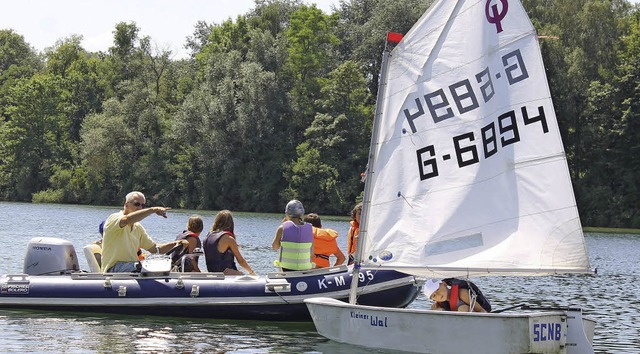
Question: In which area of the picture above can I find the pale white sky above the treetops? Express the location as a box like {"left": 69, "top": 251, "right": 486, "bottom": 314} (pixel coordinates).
{"left": 0, "top": 0, "right": 339, "bottom": 59}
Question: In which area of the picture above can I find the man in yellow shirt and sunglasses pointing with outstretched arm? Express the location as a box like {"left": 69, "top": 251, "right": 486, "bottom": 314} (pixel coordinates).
{"left": 101, "top": 192, "right": 189, "bottom": 273}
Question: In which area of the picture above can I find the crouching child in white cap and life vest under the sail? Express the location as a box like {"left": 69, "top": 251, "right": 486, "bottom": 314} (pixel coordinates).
{"left": 423, "top": 278, "right": 491, "bottom": 312}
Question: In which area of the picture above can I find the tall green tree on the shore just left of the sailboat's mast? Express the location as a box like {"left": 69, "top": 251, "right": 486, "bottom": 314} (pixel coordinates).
{"left": 288, "top": 61, "right": 374, "bottom": 214}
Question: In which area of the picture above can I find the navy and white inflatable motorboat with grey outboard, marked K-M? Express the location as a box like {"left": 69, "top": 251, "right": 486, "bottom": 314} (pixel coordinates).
{"left": 0, "top": 237, "right": 421, "bottom": 321}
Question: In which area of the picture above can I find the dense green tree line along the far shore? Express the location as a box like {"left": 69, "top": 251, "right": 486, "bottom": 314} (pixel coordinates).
{"left": 0, "top": 0, "right": 640, "bottom": 227}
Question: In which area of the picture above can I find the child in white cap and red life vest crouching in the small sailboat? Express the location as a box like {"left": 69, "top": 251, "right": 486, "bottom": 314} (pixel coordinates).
{"left": 423, "top": 278, "right": 491, "bottom": 312}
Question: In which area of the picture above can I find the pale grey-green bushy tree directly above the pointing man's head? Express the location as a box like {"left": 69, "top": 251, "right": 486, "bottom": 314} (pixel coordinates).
{"left": 81, "top": 83, "right": 172, "bottom": 203}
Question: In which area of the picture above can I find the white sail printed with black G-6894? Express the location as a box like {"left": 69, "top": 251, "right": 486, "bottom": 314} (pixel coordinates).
{"left": 358, "top": 0, "right": 589, "bottom": 277}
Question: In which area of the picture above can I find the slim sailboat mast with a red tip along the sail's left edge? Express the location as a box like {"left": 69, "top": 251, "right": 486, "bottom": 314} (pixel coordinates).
{"left": 349, "top": 32, "right": 402, "bottom": 304}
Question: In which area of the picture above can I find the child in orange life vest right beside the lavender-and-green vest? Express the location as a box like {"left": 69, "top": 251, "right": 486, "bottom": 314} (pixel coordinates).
{"left": 304, "top": 213, "right": 345, "bottom": 268}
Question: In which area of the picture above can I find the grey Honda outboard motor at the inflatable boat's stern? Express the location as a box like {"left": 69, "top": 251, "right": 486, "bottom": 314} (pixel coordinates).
{"left": 22, "top": 237, "right": 80, "bottom": 275}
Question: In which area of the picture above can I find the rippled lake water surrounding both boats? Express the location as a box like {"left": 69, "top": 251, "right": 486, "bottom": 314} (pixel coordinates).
{"left": 0, "top": 202, "right": 640, "bottom": 353}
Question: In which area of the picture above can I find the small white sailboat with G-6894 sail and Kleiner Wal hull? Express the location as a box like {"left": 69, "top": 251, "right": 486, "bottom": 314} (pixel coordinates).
{"left": 305, "top": 0, "right": 595, "bottom": 353}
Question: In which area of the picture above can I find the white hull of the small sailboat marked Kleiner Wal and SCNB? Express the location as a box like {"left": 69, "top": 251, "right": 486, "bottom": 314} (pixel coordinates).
{"left": 305, "top": 298, "right": 595, "bottom": 354}
